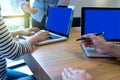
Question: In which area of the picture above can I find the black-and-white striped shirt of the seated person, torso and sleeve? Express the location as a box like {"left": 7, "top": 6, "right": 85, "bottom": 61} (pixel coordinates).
{"left": 0, "top": 7, "right": 31, "bottom": 80}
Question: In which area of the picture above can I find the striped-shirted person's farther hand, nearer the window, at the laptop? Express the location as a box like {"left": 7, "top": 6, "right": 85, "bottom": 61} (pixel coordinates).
{"left": 21, "top": 27, "right": 40, "bottom": 36}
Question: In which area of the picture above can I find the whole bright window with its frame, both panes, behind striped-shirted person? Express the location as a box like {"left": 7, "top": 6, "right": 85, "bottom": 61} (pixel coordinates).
{"left": 0, "top": 0, "right": 29, "bottom": 31}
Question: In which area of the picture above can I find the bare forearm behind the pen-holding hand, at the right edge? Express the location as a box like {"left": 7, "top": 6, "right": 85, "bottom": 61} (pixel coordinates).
{"left": 106, "top": 44, "right": 120, "bottom": 58}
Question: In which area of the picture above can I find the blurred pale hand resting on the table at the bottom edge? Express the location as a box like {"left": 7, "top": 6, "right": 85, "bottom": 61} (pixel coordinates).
{"left": 62, "top": 68, "right": 93, "bottom": 80}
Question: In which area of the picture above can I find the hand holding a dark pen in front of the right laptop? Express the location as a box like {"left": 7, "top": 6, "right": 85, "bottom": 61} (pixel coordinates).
{"left": 81, "top": 34, "right": 108, "bottom": 53}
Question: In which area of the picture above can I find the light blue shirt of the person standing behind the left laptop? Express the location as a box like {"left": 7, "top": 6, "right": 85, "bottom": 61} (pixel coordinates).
{"left": 21, "top": 0, "right": 70, "bottom": 22}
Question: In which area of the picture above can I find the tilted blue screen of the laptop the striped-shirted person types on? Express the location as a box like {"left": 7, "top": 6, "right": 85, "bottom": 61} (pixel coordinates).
{"left": 46, "top": 7, "right": 72, "bottom": 36}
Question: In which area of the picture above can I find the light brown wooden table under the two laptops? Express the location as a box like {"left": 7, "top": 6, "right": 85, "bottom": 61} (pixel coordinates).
{"left": 24, "top": 27, "right": 120, "bottom": 80}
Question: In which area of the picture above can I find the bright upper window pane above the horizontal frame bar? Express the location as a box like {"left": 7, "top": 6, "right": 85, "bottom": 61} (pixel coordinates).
{"left": 1, "top": 0, "right": 24, "bottom": 16}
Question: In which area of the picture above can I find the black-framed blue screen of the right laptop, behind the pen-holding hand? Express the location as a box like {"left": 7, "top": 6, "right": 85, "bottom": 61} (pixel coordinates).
{"left": 82, "top": 8, "right": 120, "bottom": 40}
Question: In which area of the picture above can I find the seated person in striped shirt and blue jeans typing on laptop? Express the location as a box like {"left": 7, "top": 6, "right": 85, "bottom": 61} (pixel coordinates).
{"left": 0, "top": 6, "right": 50, "bottom": 80}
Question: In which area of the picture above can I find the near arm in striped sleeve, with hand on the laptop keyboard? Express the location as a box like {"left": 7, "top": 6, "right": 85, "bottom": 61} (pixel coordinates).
{"left": 0, "top": 7, "right": 50, "bottom": 59}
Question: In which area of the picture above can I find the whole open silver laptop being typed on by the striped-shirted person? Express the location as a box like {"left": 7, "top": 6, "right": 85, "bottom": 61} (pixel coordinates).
{"left": 23, "top": 5, "right": 74, "bottom": 45}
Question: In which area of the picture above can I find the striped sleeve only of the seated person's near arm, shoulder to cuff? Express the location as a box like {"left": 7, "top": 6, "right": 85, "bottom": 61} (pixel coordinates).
{"left": 0, "top": 8, "right": 31, "bottom": 59}
